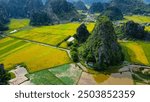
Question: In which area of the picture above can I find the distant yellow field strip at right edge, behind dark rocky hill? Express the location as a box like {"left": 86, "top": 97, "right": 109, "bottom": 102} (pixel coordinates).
{"left": 124, "top": 15, "right": 150, "bottom": 23}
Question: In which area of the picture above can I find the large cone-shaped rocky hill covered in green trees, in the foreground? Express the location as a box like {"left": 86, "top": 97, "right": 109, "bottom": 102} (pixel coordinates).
{"left": 80, "top": 16, "right": 124, "bottom": 70}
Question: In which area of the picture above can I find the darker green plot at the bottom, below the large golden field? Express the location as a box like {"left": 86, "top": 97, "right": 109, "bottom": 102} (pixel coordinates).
{"left": 27, "top": 70, "right": 64, "bottom": 85}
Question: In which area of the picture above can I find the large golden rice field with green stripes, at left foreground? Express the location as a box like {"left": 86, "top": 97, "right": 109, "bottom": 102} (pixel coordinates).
{"left": 0, "top": 38, "right": 71, "bottom": 73}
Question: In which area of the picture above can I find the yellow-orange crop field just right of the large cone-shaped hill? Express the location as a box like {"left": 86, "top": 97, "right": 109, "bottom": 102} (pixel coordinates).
{"left": 124, "top": 42, "right": 149, "bottom": 65}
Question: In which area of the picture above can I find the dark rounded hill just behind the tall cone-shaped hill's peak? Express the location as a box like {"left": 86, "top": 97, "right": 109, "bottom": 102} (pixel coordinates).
{"left": 102, "top": 7, "right": 123, "bottom": 21}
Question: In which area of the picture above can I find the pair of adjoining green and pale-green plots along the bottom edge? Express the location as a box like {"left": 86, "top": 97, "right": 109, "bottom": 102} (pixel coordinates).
{"left": 27, "top": 64, "right": 82, "bottom": 85}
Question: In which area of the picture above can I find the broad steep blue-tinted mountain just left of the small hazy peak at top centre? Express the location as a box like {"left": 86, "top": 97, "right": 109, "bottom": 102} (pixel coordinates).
{"left": 46, "top": 0, "right": 78, "bottom": 21}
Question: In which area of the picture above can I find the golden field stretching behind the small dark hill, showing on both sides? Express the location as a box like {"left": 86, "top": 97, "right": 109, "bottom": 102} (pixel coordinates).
{"left": 10, "top": 20, "right": 94, "bottom": 45}
